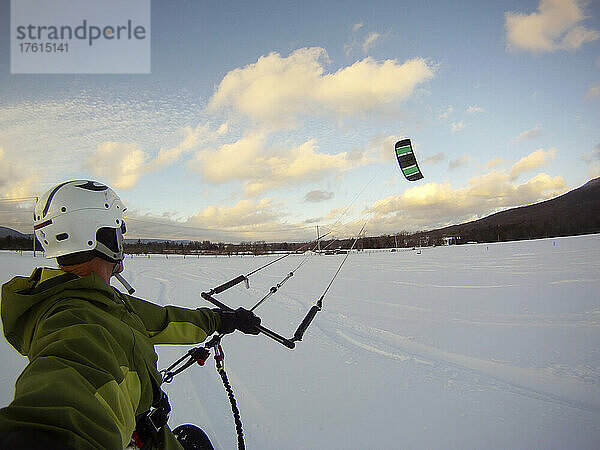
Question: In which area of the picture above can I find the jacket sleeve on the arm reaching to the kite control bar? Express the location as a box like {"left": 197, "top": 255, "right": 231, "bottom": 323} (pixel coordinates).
{"left": 123, "top": 294, "right": 221, "bottom": 344}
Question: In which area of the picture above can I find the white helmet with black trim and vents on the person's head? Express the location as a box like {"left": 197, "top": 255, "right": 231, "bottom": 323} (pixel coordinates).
{"left": 33, "top": 180, "right": 126, "bottom": 265}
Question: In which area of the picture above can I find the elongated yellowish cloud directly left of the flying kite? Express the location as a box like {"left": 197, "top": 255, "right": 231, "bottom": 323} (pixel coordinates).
{"left": 189, "top": 131, "right": 371, "bottom": 196}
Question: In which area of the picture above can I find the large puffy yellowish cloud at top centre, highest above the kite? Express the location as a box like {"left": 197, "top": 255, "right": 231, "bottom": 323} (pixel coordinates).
{"left": 209, "top": 47, "right": 434, "bottom": 127}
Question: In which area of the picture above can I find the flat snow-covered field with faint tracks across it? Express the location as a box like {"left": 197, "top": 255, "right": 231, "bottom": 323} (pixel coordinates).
{"left": 0, "top": 235, "right": 600, "bottom": 449}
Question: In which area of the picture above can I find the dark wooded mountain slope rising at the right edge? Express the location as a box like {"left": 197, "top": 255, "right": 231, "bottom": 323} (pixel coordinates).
{"left": 425, "top": 178, "right": 600, "bottom": 242}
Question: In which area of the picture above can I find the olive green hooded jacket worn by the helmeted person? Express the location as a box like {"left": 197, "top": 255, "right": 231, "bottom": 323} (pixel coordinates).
{"left": 0, "top": 268, "right": 221, "bottom": 449}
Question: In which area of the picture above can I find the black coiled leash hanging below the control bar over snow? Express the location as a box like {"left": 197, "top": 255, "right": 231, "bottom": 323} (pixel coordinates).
{"left": 161, "top": 334, "right": 246, "bottom": 450}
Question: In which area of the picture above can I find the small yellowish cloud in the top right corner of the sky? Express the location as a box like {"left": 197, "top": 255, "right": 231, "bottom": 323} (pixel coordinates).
{"left": 505, "top": 0, "right": 600, "bottom": 53}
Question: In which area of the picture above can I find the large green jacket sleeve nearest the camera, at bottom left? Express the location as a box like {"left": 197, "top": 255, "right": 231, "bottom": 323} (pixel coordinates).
{"left": 0, "top": 304, "right": 141, "bottom": 449}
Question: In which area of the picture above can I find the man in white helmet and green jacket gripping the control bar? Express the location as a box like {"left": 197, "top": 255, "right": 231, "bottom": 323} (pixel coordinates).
{"left": 0, "top": 180, "right": 260, "bottom": 450}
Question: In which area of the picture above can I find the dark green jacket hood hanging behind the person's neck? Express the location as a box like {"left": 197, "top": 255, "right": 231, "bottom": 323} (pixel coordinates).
{"left": 0, "top": 267, "right": 115, "bottom": 356}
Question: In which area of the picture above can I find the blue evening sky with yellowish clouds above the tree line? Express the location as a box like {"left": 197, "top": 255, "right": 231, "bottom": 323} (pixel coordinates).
{"left": 0, "top": 0, "right": 600, "bottom": 242}
